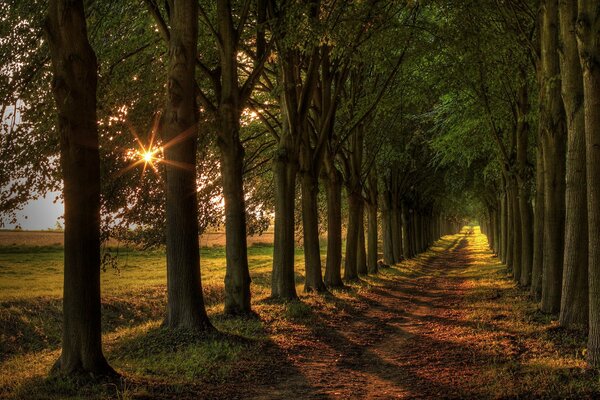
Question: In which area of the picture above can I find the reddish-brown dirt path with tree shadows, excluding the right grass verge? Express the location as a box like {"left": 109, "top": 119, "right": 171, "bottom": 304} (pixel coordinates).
{"left": 252, "top": 232, "right": 493, "bottom": 399}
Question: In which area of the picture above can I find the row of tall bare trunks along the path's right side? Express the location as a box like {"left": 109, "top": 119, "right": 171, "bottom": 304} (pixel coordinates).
{"left": 480, "top": 0, "right": 600, "bottom": 366}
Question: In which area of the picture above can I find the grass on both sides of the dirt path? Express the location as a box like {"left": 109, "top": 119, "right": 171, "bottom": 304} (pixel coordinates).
{"left": 0, "top": 230, "right": 600, "bottom": 399}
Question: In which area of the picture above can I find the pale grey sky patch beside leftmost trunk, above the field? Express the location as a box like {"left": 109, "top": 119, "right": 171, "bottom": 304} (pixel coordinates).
{"left": 2, "top": 192, "right": 64, "bottom": 230}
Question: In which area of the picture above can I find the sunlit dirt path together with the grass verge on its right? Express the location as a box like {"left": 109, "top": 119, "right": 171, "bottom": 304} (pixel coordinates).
{"left": 259, "top": 228, "right": 600, "bottom": 399}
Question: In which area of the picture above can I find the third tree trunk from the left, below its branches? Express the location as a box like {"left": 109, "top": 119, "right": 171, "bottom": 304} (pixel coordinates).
{"left": 219, "top": 120, "right": 251, "bottom": 315}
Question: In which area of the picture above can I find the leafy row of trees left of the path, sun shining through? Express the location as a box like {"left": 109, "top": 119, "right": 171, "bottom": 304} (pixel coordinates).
{"left": 0, "top": 0, "right": 472, "bottom": 375}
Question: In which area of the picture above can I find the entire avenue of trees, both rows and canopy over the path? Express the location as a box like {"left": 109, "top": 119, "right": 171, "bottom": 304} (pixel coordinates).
{"left": 0, "top": 0, "right": 600, "bottom": 375}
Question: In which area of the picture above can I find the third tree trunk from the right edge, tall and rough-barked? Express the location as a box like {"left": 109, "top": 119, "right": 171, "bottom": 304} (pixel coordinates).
{"left": 540, "top": 0, "right": 566, "bottom": 313}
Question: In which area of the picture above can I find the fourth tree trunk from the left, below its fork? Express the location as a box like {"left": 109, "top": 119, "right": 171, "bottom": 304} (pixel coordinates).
{"left": 271, "top": 135, "right": 298, "bottom": 300}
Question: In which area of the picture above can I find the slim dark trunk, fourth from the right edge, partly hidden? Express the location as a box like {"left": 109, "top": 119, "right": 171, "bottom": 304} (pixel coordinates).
{"left": 530, "top": 147, "right": 545, "bottom": 300}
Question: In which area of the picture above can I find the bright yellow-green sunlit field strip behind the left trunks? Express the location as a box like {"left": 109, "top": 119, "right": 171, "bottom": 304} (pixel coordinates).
{"left": 0, "top": 238, "right": 304, "bottom": 300}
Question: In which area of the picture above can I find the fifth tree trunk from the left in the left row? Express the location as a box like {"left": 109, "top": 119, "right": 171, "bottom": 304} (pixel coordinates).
{"left": 302, "top": 172, "right": 326, "bottom": 292}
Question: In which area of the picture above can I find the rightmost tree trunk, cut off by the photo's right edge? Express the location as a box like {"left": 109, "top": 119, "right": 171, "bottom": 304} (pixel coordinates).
{"left": 577, "top": 0, "right": 600, "bottom": 367}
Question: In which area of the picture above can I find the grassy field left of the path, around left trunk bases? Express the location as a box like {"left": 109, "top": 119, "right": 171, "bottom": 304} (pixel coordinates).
{"left": 0, "top": 231, "right": 324, "bottom": 399}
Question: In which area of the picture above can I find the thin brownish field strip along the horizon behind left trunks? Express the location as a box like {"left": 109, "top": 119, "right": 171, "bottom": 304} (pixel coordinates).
{"left": 0, "top": 230, "right": 273, "bottom": 247}
